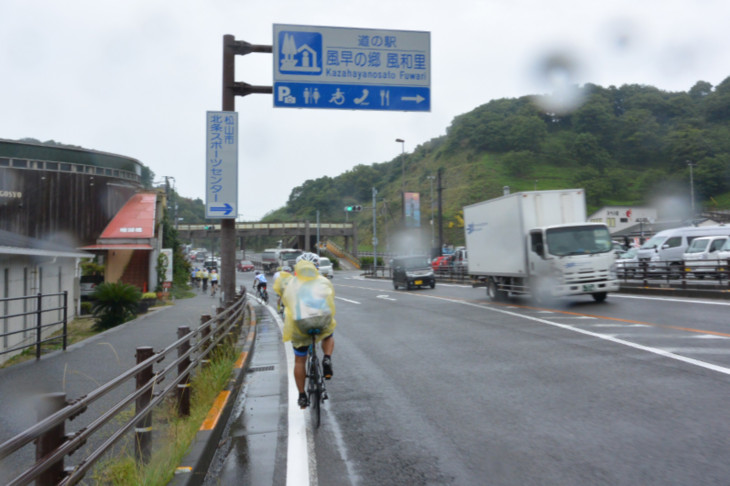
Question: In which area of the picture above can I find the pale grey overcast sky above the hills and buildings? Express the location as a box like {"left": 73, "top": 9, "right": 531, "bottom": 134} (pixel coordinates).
{"left": 0, "top": 0, "right": 730, "bottom": 221}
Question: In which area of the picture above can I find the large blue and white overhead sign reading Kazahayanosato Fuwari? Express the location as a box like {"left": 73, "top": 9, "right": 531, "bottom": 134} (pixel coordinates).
{"left": 273, "top": 24, "right": 431, "bottom": 111}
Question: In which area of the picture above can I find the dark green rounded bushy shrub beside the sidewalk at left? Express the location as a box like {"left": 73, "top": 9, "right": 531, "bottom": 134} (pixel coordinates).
{"left": 93, "top": 282, "right": 142, "bottom": 330}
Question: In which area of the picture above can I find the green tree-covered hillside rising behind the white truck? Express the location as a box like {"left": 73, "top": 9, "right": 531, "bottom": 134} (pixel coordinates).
{"left": 265, "top": 78, "right": 730, "bottom": 249}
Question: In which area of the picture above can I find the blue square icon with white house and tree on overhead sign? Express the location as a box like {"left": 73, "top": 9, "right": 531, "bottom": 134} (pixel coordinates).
{"left": 278, "top": 31, "right": 322, "bottom": 75}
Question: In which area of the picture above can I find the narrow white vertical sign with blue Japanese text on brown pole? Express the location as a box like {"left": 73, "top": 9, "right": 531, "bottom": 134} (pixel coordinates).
{"left": 205, "top": 111, "right": 238, "bottom": 219}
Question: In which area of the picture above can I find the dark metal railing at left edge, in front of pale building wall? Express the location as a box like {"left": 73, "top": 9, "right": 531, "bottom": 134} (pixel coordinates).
{"left": 0, "top": 291, "right": 68, "bottom": 359}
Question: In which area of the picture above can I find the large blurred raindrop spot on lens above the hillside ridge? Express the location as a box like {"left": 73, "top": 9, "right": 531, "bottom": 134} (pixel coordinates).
{"left": 533, "top": 50, "right": 584, "bottom": 114}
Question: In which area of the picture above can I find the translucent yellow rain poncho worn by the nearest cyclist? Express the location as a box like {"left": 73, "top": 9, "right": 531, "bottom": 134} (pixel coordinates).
{"left": 282, "top": 260, "right": 337, "bottom": 347}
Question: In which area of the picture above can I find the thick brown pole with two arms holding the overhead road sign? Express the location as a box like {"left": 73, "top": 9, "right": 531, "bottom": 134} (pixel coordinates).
{"left": 220, "top": 34, "right": 273, "bottom": 304}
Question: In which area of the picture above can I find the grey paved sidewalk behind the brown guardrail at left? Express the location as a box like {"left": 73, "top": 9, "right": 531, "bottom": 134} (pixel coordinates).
{"left": 0, "top": 294, "right": 225, "bottom": 484}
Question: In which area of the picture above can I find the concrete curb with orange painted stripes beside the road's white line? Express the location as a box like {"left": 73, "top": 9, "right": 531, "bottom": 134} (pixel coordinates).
{"left": 168, "top": 302, "right": 256, "bottom": 486}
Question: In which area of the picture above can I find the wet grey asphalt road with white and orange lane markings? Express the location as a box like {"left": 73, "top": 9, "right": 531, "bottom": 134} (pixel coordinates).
{"left": 209, "top": 272, "right": 730, "bottom": 486}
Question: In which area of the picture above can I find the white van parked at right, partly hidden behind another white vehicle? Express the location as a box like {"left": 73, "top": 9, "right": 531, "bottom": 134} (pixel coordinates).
{"left": 638, "top": 225, "right": 730, "bottom": 274}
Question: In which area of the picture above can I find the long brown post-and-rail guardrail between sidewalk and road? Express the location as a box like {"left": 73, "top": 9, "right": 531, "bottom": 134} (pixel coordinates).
{"left": 0, "top": 289, "right": 247, "bottom": 486}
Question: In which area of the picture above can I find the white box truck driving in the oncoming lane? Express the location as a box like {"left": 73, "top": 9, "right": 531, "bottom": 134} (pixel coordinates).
{"left": 464, "top": 189, "right": 619, "bottom": 302}
